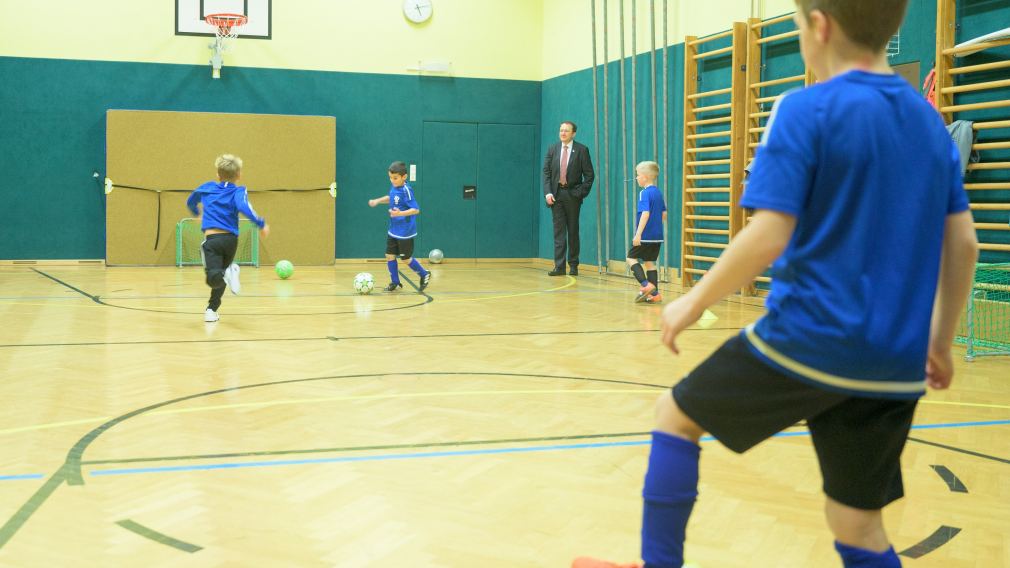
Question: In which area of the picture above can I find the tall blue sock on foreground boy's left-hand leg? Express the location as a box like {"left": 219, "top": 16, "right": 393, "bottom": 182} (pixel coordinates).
{"left": 641, "top": 432, "right": 701, "bottom": 568}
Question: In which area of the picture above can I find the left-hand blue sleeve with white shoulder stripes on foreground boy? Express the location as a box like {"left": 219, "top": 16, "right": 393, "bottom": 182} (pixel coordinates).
{"left": 740, "top": 91, "right": 819, "bottom": 216}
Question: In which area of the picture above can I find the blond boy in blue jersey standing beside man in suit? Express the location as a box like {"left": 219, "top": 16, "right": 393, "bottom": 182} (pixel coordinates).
{"left": 627, "top": 162, "right": 667, "bottom": 304}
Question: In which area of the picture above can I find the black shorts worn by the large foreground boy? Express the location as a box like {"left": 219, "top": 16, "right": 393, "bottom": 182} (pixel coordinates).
{"left": 673, "top": 336, "right": 918, "bottom": 510}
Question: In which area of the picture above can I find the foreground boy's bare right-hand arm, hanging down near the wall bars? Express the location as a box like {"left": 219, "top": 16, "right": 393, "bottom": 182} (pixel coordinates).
{"left": 926, "top": 211, "right": 979, "bottom": 389}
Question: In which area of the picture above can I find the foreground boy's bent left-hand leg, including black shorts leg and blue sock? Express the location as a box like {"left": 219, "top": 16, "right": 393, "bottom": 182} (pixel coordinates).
{"left": 577, "top": 336, "right": 848, "bottom": 568}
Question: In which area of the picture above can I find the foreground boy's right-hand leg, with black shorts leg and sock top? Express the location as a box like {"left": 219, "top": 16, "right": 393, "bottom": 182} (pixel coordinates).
{"left": 808, "top": 398, "right": 917, "bottom": 568}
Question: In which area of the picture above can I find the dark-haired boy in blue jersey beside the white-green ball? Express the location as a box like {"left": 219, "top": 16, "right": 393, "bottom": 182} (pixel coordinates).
{"left": 369, "top": 162, "right": 431, "bottom": 292}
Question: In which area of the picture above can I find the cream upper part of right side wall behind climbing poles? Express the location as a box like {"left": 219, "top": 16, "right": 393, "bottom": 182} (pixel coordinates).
{"left": 543, "top": 0, "right": 796, "bottom": 79}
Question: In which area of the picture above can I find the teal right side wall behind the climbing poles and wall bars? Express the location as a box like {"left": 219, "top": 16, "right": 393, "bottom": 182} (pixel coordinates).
{"left": 539, "top": 0, "right": 1010, "bottom": 267}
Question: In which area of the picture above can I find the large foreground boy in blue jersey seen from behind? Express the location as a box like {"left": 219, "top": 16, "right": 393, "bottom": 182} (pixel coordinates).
{"left": 575, "top": 0, "right": 978, "bottom": 568}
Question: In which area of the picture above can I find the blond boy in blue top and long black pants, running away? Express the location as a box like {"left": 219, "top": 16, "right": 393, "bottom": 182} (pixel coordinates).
{"left": 186, "top": 154, "right": 270, "bottom": 322}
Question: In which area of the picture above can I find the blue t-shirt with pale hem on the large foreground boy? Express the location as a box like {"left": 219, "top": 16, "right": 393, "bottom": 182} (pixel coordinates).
{"left": 740, "top": 71, "right": 969, "bottom": 398}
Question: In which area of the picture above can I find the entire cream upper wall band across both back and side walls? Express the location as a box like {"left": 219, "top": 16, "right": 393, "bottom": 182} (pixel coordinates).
{"left": 0, "top": 0, "right": 795, "bottom": 81}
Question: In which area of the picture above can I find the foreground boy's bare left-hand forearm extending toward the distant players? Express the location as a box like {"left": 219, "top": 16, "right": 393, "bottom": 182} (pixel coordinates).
{"left": 663, "top": 209, "right": 796, "bottom": 354}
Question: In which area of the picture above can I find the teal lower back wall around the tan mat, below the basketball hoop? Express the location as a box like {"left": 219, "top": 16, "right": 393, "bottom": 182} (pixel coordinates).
{"left": 0, "top": 58, "right": 540, "bottom": 259}
